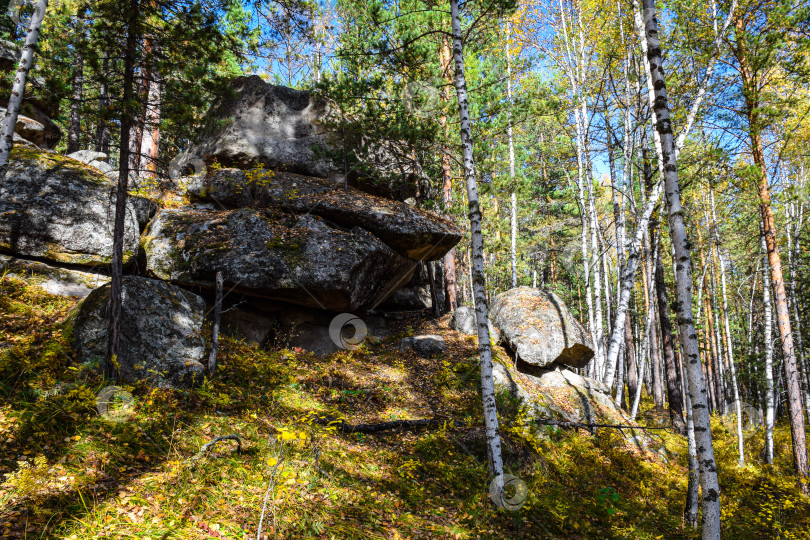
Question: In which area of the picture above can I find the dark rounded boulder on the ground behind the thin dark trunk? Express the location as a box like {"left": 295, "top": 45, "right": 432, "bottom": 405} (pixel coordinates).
{"left": 73, "top": 276, "right": 205, "bottom": 387}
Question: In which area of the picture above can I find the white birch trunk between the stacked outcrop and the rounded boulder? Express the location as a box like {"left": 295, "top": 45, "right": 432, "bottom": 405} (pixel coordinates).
{"left": 450, "top": 0, "right": 503, "bottom": 479}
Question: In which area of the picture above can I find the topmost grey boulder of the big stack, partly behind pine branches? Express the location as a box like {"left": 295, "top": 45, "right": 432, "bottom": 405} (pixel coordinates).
{"left": 190, "top": 75, "right": 427, "bottom": 200}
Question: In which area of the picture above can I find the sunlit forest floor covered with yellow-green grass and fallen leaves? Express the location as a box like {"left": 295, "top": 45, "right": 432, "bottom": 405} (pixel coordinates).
{"left": 0, "top": 276, "right": 810, "bottom": 539}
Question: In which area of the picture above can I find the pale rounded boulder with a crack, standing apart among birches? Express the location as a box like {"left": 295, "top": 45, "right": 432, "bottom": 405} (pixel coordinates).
{"left": 490, "top": 286, "right": 594, "bottom": 368}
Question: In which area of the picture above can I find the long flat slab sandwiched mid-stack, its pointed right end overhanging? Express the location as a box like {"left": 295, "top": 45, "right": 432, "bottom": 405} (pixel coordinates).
{"left": 188, "top": 169, "right": 462, "bottom": 260}
